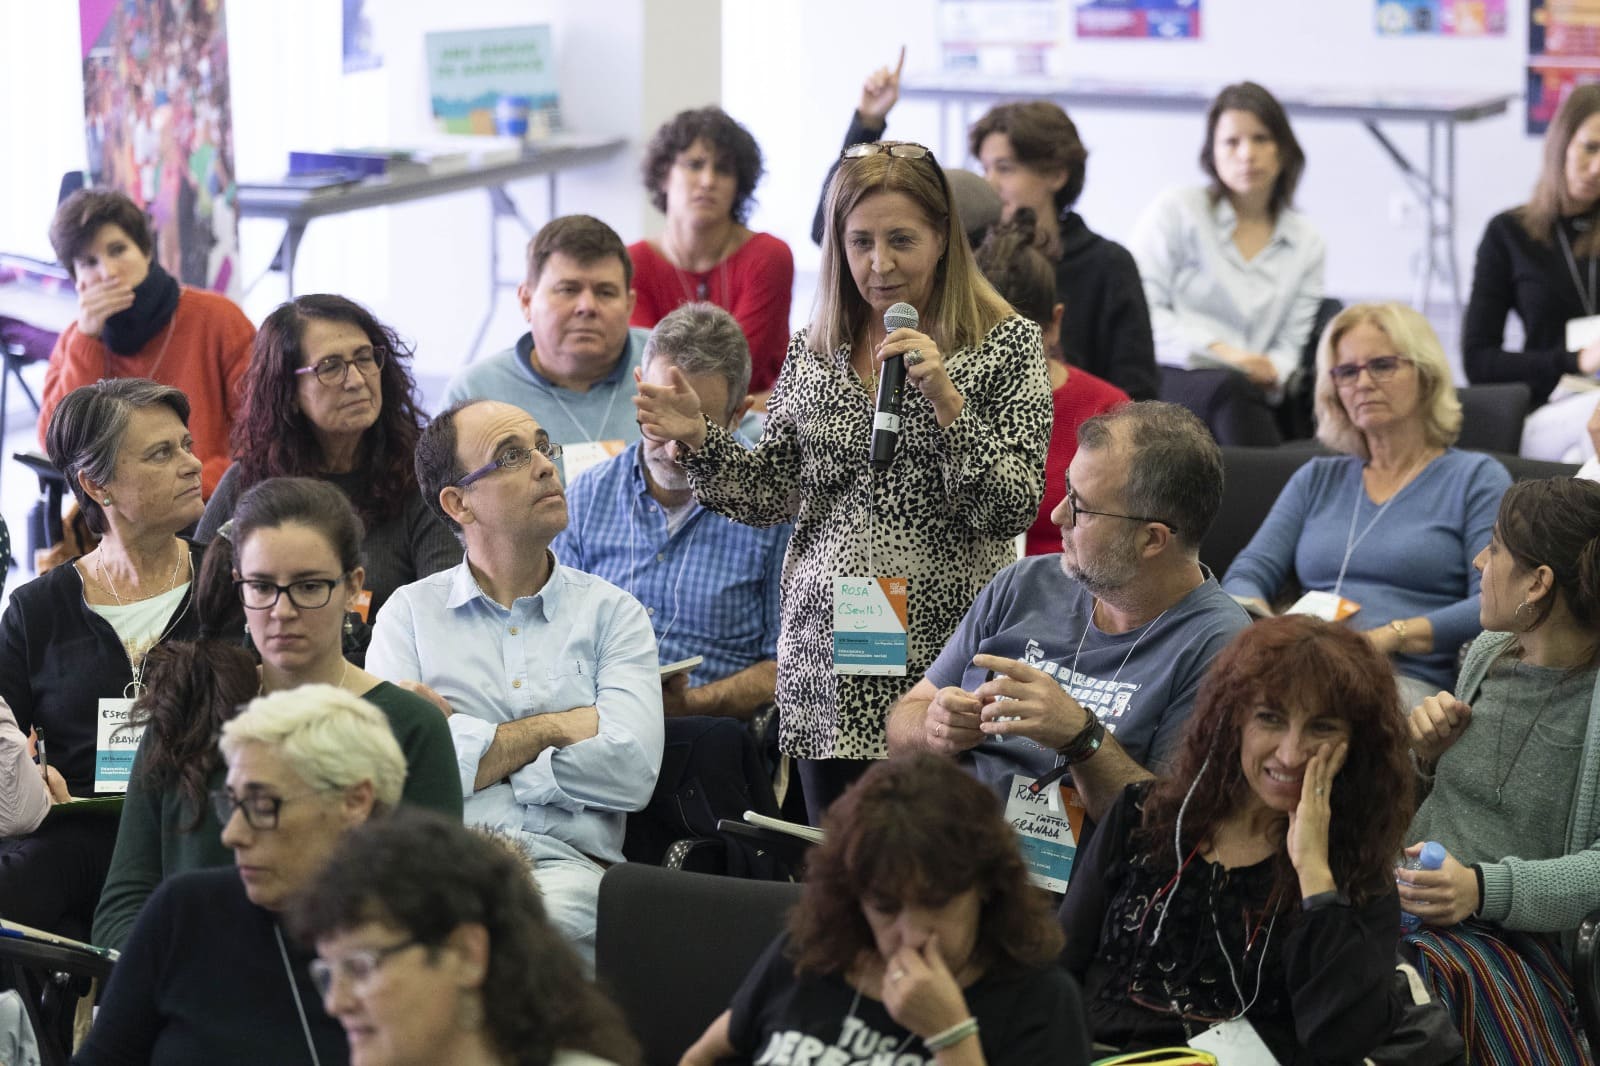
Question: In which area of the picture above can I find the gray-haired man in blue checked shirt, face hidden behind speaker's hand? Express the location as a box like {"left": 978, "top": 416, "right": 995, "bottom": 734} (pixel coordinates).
{"left": 554, "top": 304, "right": 790, "bottom": 719}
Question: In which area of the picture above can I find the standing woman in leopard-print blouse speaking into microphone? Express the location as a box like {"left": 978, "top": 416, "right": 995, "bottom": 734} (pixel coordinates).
{"left": 634, "top": 141, "right": 1051, "bottom": 824}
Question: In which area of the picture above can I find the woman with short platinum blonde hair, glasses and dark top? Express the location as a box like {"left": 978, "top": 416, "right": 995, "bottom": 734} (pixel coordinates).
{"left": 72, "top": 681, "right": 408, "bottom": 1066}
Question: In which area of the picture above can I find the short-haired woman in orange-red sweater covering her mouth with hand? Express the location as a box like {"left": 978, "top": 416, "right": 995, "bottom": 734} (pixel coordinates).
{"left": 38, "top": 189, "right": 256, "bottom": 496}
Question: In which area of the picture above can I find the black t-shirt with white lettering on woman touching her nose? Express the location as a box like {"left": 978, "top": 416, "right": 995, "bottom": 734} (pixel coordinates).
{"left": 728, "top": 935, "right": 1090, "bottom": 1066}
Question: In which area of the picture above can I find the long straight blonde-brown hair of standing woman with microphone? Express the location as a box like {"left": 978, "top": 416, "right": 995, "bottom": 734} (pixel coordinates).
{"left": 806, "top": 141, "right": 1014, "bottom": 354}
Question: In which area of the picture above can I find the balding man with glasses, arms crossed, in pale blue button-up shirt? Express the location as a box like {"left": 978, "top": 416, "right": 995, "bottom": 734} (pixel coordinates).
{"left": 366, "top": 393, "right": 662, "bottom": 959}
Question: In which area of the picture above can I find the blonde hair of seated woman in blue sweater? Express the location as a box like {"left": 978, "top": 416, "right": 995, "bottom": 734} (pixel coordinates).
{"left": 1315, "top": 303, "right": 1461, "bottom": 459}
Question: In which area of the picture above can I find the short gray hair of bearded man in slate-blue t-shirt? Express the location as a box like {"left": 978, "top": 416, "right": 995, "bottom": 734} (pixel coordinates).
{"left": 1078, "top": 400, "right": 1222, "bottom": 552}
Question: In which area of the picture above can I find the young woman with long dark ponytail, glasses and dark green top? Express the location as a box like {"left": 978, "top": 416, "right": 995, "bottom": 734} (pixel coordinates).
{"left": 94, "top": 477, "right": 461, "bottom": 946}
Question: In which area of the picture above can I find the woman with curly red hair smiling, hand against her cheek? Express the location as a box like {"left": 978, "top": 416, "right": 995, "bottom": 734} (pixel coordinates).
{"left": 1061, "top": 615, "right": 1411, "bottom": 1063}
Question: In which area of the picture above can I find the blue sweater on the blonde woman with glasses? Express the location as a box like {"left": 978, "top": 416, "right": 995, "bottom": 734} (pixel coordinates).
{"left": 1222, "top": 448, "right": 1510, "bottom": 688}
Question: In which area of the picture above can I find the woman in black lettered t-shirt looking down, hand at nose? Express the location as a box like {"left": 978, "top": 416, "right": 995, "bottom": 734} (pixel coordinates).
{"left": 683, "top": 754, "right": 1088, "bottom": 1066}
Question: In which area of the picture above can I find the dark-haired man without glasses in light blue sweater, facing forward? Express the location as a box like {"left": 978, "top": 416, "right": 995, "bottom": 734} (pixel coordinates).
{"left": 445, "top": 214, "right": 650, "bottom": 483}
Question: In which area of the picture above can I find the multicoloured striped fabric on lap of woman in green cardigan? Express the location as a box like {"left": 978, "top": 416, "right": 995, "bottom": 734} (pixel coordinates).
{"left": 1402, "top": 919, "right": 1595, "bottom": 1066}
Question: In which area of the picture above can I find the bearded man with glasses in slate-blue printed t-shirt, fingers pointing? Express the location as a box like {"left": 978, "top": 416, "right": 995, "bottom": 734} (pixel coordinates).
{"left": 888, "top": 400, "right": 1250, "bottom": 816}
